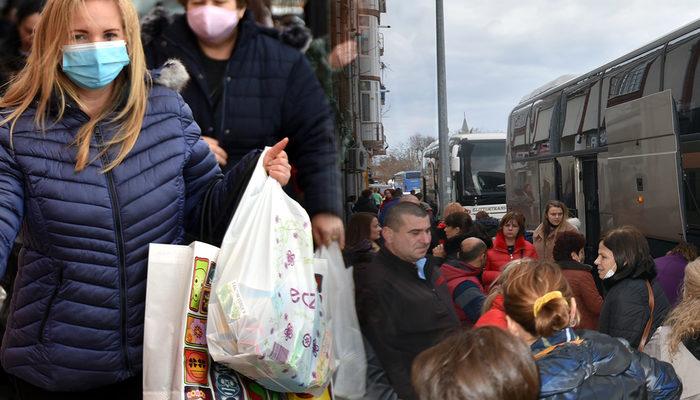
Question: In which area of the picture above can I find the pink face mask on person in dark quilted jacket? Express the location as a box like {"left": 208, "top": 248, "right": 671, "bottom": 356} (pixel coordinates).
{"left": 187, "top": 5, "right": 238, "bottom": 44}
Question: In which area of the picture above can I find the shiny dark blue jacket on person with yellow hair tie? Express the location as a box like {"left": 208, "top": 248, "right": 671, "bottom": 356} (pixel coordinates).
{"left": 531, "top": 328, "right": 683, "bottom": 400}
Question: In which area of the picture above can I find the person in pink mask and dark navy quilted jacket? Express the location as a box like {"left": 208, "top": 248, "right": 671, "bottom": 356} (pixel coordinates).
{"left": 142, "top": 0, "right": 344, "bottom": 245}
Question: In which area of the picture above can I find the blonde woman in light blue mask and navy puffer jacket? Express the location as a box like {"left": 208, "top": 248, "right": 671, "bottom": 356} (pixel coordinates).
{"left": 0, "top": 0, "right": 290, "bottom": 399}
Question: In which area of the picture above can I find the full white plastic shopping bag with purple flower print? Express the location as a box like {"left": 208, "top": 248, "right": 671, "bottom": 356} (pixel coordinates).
{"left": 207, "top": 148, "right": 332, "bottom": 394}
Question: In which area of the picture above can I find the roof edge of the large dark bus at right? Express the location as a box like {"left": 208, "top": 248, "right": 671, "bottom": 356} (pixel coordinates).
{"left": 509, "top": 19, "right": 700, "bottom": 109}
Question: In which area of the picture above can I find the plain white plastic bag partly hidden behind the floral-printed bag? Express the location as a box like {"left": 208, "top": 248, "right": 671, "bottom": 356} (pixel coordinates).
{"left": 316, "top": 242, "right": 367, "bottom": 400}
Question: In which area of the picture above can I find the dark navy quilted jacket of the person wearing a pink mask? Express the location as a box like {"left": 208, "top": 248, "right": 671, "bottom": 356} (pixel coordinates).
{"left": 143, "top": 12, "right": 343, "bottom": 217}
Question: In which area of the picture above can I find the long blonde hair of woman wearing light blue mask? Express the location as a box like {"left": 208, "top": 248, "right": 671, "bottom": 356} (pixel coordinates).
{"left": 0, "top": 0, "right": 151, "bottom": 172}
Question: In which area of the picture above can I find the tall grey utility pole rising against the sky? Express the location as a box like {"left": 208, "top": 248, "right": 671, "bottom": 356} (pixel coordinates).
{"left": 435, "top": 0, "right": 452, "bottom": 213}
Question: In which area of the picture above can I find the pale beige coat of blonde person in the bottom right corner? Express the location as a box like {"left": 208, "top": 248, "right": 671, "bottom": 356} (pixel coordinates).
{"left": 644, "top": 326, "right": 700, "bottom": 400}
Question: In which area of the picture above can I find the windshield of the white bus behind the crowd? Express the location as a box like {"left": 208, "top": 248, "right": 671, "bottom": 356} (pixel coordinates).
{"left": 462, "top": 140, "right": 506, "bottom": 195}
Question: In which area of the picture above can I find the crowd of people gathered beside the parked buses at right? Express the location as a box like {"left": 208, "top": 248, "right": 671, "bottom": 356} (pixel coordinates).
{"left": 346, "top": 191, "right": 700, "bottom": 400}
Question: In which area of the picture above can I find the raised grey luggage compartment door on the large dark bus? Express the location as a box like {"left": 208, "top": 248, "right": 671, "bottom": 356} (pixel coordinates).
{"left": 605, "top": 90, "right": 685, "bottom": 241}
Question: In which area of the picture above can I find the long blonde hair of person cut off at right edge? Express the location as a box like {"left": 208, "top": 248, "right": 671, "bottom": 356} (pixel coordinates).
{"left": 665, "top": 259, "right": 700, "bottom": 355}
